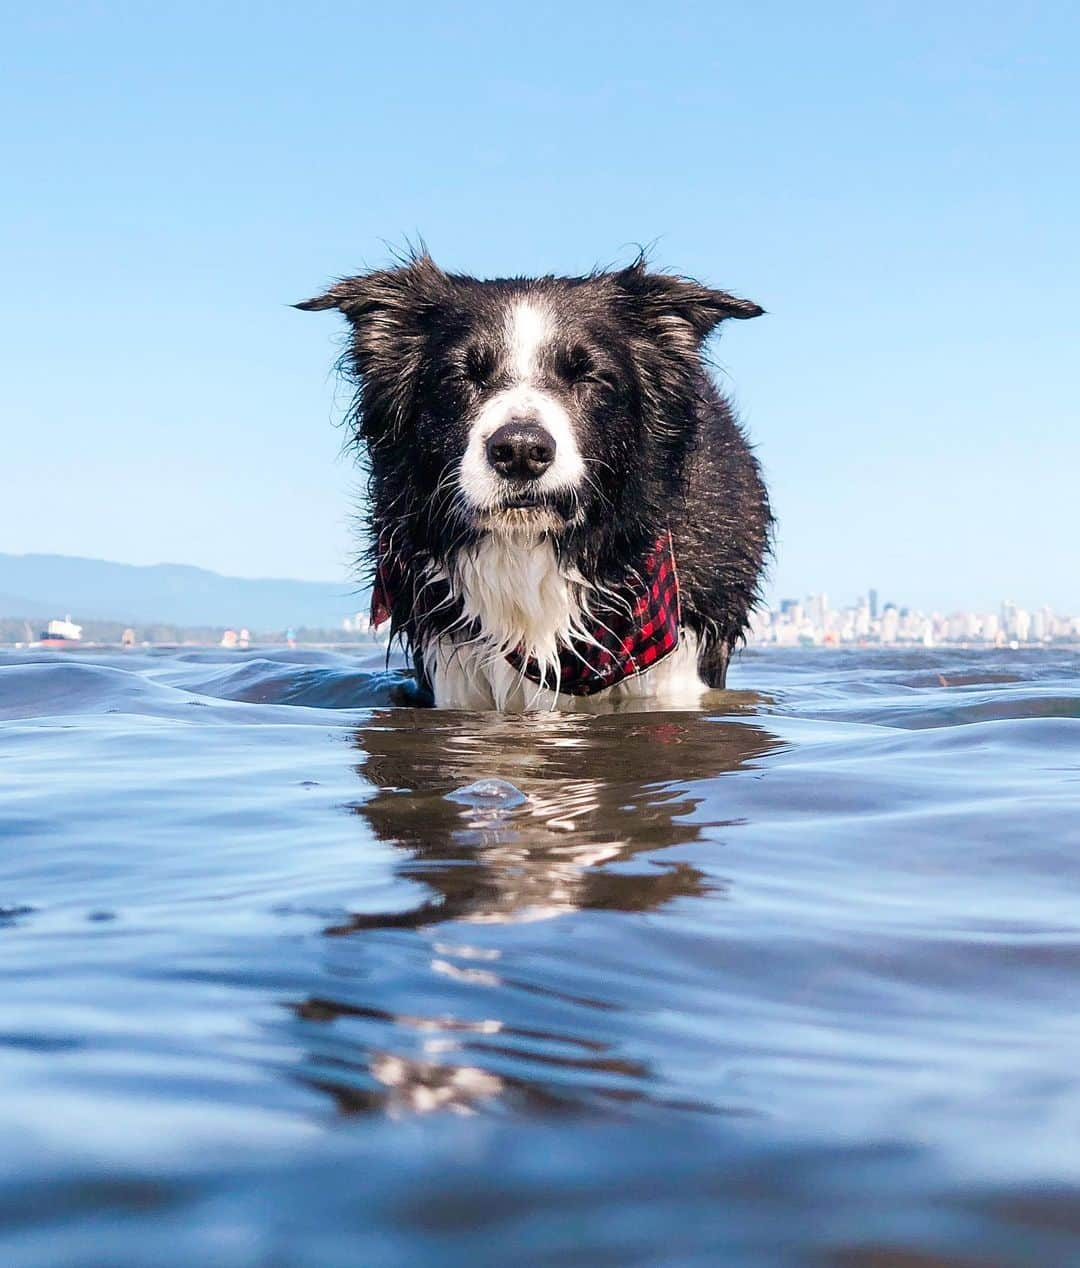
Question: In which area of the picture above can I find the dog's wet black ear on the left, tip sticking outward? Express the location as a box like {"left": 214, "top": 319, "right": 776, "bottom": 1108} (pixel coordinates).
{"left": 293, "top": 254, "right": 450, "bottom": 418}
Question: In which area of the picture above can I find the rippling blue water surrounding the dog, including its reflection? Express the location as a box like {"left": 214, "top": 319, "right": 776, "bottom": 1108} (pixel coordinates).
{"left": 0, "top": 649, "right": 1080, "bottom": 1268}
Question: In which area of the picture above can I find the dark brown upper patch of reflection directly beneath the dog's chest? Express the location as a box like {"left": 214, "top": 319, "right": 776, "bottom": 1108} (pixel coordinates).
{"left": 328, "top": 710, "right": 777, "bottom": 933}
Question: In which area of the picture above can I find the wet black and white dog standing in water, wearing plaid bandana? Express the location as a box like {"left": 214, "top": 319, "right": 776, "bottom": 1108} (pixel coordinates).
{"left": 298, "top": 254, "right": 771, "bottom": 711}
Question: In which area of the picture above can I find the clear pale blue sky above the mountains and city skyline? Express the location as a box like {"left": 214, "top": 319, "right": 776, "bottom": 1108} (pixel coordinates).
{"left": 0, "top": 0, "right": 1080, "bottom": 611}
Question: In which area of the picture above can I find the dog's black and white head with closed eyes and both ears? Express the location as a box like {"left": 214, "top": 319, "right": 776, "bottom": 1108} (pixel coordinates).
{"left": 297, "top": 255, "right": 762, "bottom": 554}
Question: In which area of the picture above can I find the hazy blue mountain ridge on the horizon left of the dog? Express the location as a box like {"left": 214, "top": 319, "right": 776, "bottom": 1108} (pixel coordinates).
{"left": 0, "top": 554, "right": 366, "bottom": 633}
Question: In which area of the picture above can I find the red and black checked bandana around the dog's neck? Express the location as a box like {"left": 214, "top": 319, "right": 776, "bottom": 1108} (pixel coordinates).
{"left": 371, "top": 533, "right": 679, "bottom": 696}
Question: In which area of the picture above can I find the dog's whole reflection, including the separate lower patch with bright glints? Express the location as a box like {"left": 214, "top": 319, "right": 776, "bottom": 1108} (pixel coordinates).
{"left": 297, "top": 709, "right": 778, "bottom": 1113}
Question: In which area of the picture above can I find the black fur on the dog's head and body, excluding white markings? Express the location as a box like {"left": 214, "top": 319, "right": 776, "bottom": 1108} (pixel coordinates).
{"left": 297, "top": 254, "right": 772, "bottom": 687}
